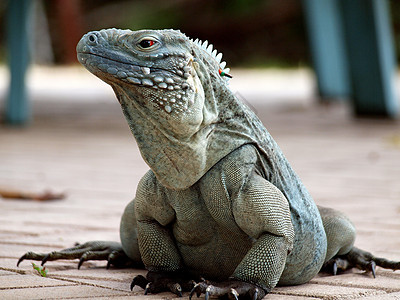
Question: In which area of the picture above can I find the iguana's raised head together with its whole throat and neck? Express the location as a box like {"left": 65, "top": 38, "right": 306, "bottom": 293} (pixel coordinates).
{"left": 77, "top": 29, "right": 248, "bottom": 189}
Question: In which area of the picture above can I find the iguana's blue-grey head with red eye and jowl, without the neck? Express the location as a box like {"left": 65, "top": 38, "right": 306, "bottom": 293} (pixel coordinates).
{"left": 77, "top": 29, "right": 231, "bottom": 139}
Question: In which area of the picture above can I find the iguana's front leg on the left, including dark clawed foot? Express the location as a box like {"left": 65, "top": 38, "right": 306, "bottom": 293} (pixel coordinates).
{"left": 131, "top": 172, "right": 194, "bottom": 296}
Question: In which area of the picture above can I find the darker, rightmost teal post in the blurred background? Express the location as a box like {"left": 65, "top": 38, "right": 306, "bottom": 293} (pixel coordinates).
{"left": 340, "top": 0, "right": 399, "bottom": 117}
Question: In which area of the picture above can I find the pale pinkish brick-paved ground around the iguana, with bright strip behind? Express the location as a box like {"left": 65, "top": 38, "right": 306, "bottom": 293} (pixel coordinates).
{"left": 0, "top": 68, "right": 400, "bottom": 300}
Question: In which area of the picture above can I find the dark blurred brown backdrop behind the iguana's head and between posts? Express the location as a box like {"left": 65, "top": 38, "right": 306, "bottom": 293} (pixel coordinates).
{"left": 0, "top": 0, "right": 400, "bottom": 68}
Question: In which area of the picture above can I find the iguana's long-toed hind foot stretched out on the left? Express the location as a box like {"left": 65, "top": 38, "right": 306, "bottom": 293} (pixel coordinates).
{"left": 17, "top": 241, "right": 138, "bottom": 269}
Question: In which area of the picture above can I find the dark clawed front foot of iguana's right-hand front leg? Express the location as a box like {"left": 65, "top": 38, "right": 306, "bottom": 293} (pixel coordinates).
{"left": 189, "top": 280, "right": 266, "bottom": 300}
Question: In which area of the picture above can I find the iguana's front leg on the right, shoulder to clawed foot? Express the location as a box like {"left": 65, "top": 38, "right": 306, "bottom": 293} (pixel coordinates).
{"left": 191, "top": 170, "right": 294, "bottom": 299}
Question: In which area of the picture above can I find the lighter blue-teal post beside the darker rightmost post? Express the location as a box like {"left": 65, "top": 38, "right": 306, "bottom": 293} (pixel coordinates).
{"left": 303, "top": 0, "right": 350, "bottom": 99}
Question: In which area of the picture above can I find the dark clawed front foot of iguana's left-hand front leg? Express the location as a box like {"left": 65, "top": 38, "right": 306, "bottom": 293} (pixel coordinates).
{"left": 131, "top": 271, "right": 195, "bottom": 297}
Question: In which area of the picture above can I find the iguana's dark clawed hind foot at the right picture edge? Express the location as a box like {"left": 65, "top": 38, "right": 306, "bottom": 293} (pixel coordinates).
{"left": 323, "top": 248, "right": 400, "bottom": 278}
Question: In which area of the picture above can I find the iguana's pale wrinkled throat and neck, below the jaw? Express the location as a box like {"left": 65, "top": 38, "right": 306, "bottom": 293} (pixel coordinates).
{"left": 110, "top": 63, "right": 247, "bottom": 189}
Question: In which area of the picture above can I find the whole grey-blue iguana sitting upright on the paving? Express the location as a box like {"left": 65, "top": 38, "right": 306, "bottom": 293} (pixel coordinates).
{"left": 18, "top": 29, "right": 400, "bottom": 299}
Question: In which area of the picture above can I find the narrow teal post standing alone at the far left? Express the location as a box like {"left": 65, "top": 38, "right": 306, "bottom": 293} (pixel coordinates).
{"left": 5, "top": 0, "right": 32, "bottom": 125}
